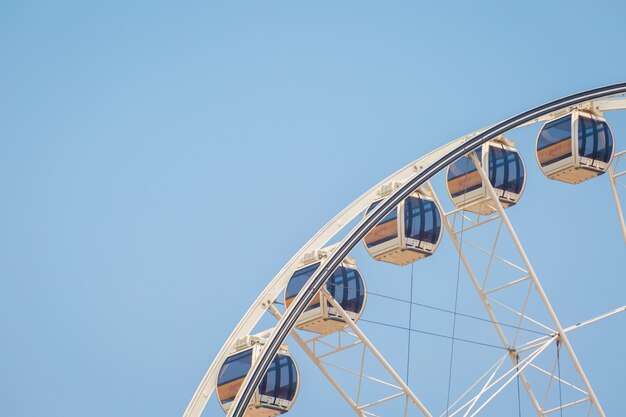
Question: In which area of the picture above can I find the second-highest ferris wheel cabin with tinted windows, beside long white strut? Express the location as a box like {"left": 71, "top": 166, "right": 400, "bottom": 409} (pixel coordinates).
{"left": 447, "top": 138, "right": 526, "bottom": 215}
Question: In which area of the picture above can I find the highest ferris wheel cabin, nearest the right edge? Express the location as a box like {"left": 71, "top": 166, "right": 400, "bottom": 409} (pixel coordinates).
{"left": 537, "top": 110, "right": 614, "bottom": 184}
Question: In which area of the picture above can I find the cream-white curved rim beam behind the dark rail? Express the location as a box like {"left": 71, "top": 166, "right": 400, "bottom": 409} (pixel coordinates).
{"left": 184, "top": 86, "right": 626, "bottom": 417}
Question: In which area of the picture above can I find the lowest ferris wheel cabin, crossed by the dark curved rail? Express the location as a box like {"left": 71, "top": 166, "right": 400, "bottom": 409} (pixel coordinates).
{"left": 216, "top": 331, "right": 299, "bottom": 417}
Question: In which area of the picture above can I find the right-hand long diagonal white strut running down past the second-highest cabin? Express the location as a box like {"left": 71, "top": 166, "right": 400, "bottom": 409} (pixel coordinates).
{"left": 470, "top": 152, "right": 606, "bottom": 417}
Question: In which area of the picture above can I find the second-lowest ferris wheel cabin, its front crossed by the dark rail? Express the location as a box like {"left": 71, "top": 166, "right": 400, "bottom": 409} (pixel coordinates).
{"left": 285, "top": 249, "right": 366, "bottom": 334}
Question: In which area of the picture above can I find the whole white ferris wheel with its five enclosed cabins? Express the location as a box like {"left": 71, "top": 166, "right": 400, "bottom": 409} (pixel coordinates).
{"left": 184, "top": 83, "right": 626, "bottom": 417}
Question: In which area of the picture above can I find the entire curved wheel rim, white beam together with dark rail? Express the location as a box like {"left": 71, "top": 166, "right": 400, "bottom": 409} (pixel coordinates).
{"left": 184, "top": 83, "right": 626, "bottom": 417}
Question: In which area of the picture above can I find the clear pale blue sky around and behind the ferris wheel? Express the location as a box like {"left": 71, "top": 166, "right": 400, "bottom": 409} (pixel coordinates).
{"left": 0, "top": 0, "right": 626, "bottom": 417}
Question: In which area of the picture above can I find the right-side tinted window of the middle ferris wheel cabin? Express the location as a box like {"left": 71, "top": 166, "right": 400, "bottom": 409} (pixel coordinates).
{"left": 404, "top": 196, "right": 438, "bottom": 243}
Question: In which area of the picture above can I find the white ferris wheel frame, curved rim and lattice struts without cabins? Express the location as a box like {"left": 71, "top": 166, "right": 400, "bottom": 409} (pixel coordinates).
{"left": 183, "top": 83, "right": 626, "bottom": 417}
